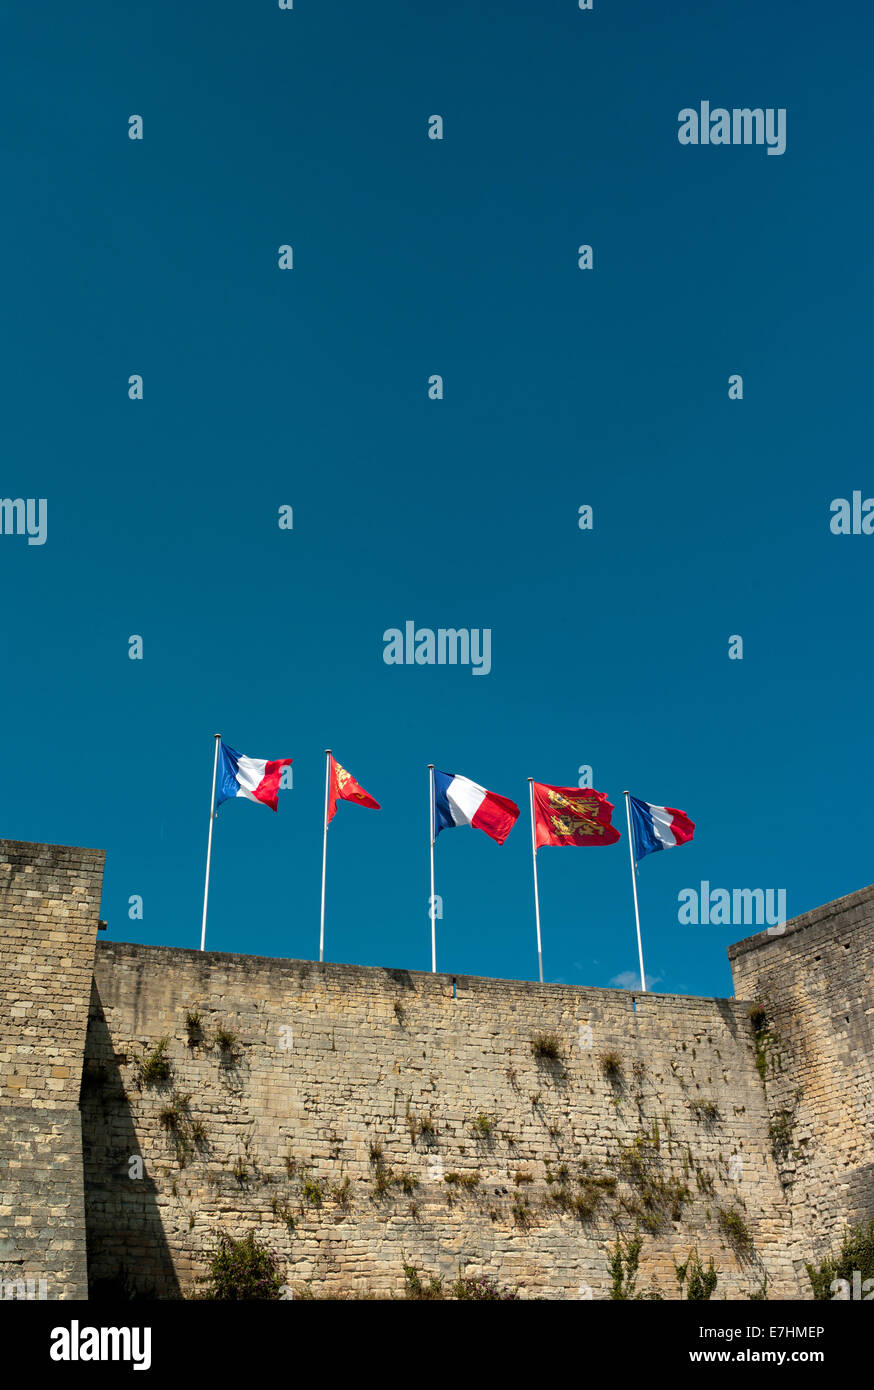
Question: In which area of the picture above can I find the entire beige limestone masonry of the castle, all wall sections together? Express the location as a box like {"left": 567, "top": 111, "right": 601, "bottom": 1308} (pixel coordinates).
{"left": 0, "top": 841, "right": 874, "bottom": 1298}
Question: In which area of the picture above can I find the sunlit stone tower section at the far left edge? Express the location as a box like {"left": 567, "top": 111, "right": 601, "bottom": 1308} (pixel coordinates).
{"left": 0, "top": 840, "right": 103, "bottom": 1298}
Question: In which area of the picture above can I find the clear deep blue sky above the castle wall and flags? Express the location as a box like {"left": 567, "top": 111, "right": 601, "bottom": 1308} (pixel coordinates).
{"left": 0, "top": 0, "right": 874, "bottom": 995}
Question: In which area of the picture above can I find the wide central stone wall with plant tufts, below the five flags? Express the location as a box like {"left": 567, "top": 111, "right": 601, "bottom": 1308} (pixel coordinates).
{"left": 83, "top": 942, "right": 803, "bottom": 1298}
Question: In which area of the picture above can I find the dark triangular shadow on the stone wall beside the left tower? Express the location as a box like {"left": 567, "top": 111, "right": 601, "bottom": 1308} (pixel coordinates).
{"left": 81, "top": 981, "right": 182, "bottom": 1301}
